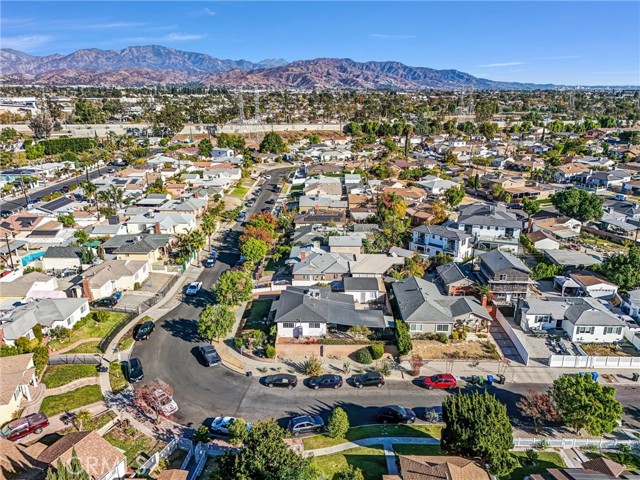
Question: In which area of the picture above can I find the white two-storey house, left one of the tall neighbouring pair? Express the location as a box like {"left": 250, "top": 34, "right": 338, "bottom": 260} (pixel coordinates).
{"left": 409, "top": 225, "right": 473, "bottom": 262}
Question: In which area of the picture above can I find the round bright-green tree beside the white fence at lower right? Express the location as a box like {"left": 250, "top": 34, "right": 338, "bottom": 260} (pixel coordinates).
{"left": 550, "top": 374, "right": 622, "bottom": 436}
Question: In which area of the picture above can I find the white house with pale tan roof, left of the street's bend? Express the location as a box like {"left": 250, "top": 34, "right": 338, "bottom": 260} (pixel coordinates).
{"left": 82, "top": 260, "right": 150, "bottom": 302}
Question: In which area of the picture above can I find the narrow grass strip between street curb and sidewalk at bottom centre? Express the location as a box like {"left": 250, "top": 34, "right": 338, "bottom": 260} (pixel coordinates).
{"left": 302, "top": 425, "right": 442, "bottom": 450}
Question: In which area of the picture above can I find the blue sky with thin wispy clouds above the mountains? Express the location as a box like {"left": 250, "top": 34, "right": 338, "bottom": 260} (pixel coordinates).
{"left": 0, "top": 0, "right": 640, "bottom": 85}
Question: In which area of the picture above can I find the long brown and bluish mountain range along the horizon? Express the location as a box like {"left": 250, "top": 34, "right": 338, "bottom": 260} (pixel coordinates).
{"left": 0, "top": 45, "right": 554, "bottom": 90}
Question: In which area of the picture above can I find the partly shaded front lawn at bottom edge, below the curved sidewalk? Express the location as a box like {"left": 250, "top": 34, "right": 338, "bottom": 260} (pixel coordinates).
{"left": 312, "top": 445, "right": 387, "bottom": 480}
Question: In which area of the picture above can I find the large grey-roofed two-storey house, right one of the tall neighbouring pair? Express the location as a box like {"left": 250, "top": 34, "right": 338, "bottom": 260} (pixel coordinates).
{"left": 458, "top": 203, "right": 522, "bottom": 253}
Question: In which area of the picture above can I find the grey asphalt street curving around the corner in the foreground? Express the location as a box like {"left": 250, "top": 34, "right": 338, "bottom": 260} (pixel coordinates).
{"left": 132, "top": 168, "right": 640, "bottom": 432}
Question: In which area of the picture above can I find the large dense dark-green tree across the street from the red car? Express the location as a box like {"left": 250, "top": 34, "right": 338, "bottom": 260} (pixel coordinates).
{"left": 440, "top": 391, "right": 515, "bottom": 476}
